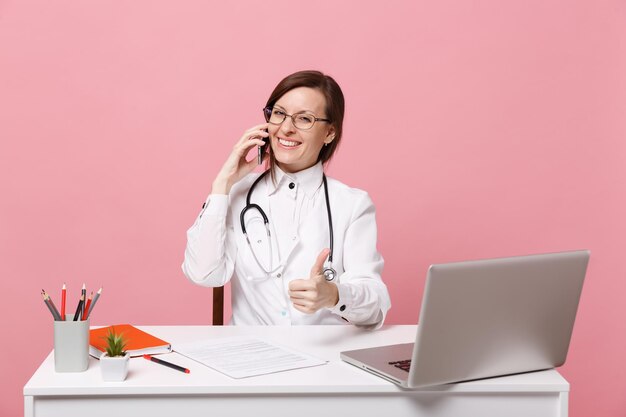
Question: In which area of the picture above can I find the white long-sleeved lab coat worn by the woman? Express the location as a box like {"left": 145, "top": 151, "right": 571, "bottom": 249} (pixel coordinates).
{"left": 182, "top": 163, "right": 391, "bottom": 328}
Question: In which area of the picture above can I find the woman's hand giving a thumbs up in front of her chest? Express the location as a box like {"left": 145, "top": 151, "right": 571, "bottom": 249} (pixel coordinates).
{"left": 289, "top": 249, "right": 339, "bottom": 314}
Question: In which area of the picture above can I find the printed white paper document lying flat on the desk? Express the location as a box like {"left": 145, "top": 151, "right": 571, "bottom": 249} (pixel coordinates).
{"left": 173, "top": 337, "right": 326, "bottom": 378}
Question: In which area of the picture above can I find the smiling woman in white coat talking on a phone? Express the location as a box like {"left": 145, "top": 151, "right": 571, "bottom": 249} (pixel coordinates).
{"left": 182, "top": 71, "right": 391, "bottom": 328}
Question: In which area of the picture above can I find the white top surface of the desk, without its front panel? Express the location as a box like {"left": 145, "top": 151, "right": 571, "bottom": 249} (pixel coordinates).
{"left": 24, "top": 325, "right": 569, "bottom": 397}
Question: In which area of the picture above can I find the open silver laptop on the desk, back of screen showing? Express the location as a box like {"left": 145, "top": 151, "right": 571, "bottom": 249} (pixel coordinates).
{"left": 341, "top": 250, "right": 590, "bottom": 388}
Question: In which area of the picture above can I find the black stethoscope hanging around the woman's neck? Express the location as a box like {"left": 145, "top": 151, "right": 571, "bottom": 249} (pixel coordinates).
{"left": 239, "top": 170, "right": 337, "bottom": 281}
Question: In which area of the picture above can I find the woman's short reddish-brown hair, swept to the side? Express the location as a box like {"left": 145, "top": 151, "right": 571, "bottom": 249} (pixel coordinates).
{"left": 265, "top": 71, "right": 345, "bottom": 177}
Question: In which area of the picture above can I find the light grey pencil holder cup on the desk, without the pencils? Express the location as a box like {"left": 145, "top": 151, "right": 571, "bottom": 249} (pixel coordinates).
{"left": 54, "top": 314, "right": 89, "bottom": 372}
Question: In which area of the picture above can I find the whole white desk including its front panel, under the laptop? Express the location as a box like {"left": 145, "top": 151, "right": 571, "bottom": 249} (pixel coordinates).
{"left": 24, "top": 326, "right": 569, "bottom": 417}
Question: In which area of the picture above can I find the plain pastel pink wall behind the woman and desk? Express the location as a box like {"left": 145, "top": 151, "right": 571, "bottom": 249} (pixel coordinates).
{"left": 0, "top": 0, "right": 626, "bottom": 417}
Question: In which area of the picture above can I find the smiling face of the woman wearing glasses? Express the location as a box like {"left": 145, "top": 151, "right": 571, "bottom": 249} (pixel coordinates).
{"left": 268, "top": 87, "right": 335, "bottom": 172}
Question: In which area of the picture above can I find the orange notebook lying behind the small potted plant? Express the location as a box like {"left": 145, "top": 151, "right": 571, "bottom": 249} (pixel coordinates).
{"left": 89, "top": 324, "right": 172, "bottom": 358}
